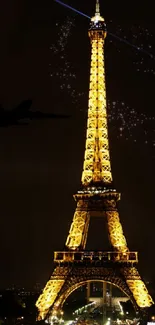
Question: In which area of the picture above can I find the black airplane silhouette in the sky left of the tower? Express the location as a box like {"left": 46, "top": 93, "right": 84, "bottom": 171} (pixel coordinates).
{"left": 0, "top": 99, "right": 69, "bottom": 127}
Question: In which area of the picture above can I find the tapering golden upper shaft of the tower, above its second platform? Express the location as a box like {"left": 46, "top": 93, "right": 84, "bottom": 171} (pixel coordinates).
{"left": 82, "top": 32, "right": 112, "bottom": 186}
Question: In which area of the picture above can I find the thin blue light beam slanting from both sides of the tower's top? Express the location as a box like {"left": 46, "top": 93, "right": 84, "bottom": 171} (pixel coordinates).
{"left": 54, "top": 0, "right": 155, "bottom": 60}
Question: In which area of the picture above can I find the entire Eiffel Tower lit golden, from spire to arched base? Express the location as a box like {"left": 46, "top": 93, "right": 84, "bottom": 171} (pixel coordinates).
{"left": 36, "top": 0, "right": 153, "bottom": 319}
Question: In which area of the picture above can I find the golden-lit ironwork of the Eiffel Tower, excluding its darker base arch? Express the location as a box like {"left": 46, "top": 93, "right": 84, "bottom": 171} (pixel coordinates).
{"left": 36, "top": 0, "right": 153, "bottom": 319}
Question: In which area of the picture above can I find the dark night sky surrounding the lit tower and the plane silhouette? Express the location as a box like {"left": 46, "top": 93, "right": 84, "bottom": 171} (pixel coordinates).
{"left": 0, "top": 0, "right": 155, "bottom": 287}
